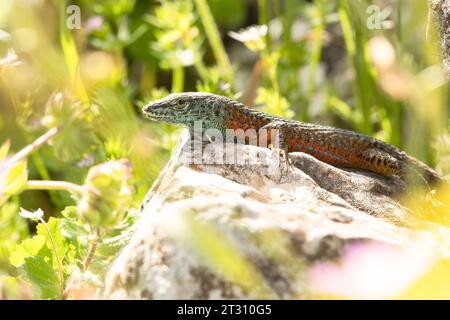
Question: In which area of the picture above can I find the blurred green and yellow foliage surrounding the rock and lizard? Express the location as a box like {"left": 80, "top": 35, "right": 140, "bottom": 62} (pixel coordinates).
{"left": 0, "top": 0, "right": 450, "bottom": 298}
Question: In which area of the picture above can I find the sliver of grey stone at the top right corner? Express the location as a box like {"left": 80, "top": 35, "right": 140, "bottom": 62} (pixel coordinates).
{"left": 429, "top": 0, "right": 450, "bottom": 81}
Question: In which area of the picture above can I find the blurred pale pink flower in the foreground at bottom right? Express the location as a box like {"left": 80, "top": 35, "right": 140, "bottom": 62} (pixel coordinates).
{"left": 307, "top": 242, "right": 431, "bottom": 299}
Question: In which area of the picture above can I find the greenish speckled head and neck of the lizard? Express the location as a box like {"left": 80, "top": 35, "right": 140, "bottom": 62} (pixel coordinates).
{"left": 142, "top": 92, "right": 232, "bottom": 129}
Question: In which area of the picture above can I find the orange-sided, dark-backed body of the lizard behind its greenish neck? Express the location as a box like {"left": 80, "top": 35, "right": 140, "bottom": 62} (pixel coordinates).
{"left": 221, "top": 103, "right": 441, "bottom": 183}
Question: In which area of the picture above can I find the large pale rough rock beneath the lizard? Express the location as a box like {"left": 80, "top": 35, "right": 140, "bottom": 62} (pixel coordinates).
{"left": 105, "top": 134, "right": 448, "bottom": 299}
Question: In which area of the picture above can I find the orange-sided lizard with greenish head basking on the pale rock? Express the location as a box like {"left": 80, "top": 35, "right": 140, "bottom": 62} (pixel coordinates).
{"left": 142, "top": 92, "right": 442, "bottom": 185}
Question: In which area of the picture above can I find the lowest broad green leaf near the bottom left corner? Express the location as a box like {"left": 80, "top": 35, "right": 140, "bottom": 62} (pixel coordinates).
{"left": 21, "top": 257, "right": 60, "bottom": 299}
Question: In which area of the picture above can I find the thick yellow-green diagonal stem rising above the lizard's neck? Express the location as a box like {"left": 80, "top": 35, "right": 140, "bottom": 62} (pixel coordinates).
{"left": 194, "top": 0, "right": 233, "bottom": 83}
